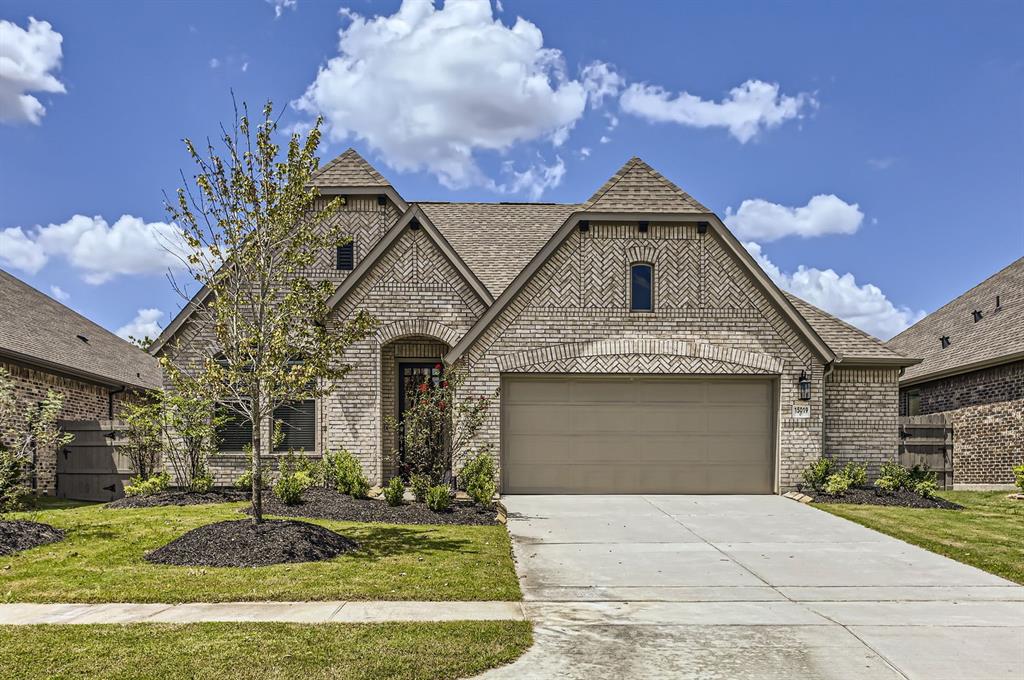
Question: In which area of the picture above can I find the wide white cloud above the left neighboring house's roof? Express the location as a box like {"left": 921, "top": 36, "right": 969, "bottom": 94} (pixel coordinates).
{"left": 0, "top": 215, "right": 190, "bottom": 285}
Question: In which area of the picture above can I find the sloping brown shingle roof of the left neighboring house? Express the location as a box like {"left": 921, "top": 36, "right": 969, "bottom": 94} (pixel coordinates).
{"left": 0, "top": 269, "right": 162, "bottom": 389}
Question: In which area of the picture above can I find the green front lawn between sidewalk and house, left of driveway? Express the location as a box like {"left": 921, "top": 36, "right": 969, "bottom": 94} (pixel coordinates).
{"left": 0, "top": 503, "right": 521, "bottom": 602}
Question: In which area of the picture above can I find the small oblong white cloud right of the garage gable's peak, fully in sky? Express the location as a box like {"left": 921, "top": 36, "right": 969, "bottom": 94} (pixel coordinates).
{"left": 725, "top": 194, "right": 864, "bottom": 242}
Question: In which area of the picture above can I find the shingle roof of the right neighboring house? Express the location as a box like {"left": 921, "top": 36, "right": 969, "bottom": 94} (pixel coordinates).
{"left": 887, "top": 257, "right": 1024, "bottom": 383}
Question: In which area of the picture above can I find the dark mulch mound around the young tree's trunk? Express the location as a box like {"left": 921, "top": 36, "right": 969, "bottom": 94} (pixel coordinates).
{"left": 145, "top": 519, "right": 357, "bottom": 566}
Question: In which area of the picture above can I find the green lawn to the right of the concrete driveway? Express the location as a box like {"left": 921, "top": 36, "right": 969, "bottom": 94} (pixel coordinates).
{"left": 815, "top": 492, "right": 1024, "bottom": 584}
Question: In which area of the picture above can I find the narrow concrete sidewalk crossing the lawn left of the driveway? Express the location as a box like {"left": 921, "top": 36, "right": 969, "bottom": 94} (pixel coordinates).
{"left": 0, "top": 601, "right": 525, "bottom": 626}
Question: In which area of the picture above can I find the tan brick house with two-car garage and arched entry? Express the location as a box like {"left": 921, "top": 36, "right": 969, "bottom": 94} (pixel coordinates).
{"left": 149, "top": 150, "right": 914, "bottom": 494}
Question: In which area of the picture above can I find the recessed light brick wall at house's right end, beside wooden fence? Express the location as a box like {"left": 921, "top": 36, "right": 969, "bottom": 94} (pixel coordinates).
{"left": 824, "top": 368, "right": 899, "bottom": 477}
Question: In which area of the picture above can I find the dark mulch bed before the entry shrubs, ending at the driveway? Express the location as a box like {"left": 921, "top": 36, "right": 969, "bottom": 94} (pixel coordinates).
{"left": 253, "top": 488, "right": 498, "bottom": 525}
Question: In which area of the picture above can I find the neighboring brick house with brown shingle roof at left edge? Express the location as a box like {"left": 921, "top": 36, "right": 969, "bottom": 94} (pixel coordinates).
{"left": 0, "top": 270, "right": 162, "bottom": 495}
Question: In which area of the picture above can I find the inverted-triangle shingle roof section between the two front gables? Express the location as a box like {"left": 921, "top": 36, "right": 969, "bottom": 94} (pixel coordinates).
{"left": 417, "top": 203, "right": 580, "bottom": 297}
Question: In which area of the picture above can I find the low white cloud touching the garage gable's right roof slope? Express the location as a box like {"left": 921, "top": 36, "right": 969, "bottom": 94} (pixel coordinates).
{"left": 743, "top": 243, "right": 925, "bottom": 340}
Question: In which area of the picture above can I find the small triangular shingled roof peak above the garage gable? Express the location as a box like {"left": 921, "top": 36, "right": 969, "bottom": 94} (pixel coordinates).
{"left": 583, "top": 157, "right": 711, "bottom": 213}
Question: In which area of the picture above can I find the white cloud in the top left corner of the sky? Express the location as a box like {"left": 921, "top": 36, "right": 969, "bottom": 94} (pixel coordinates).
{"left": 0, "top": 16, "right": 66, "bottom": 125}
